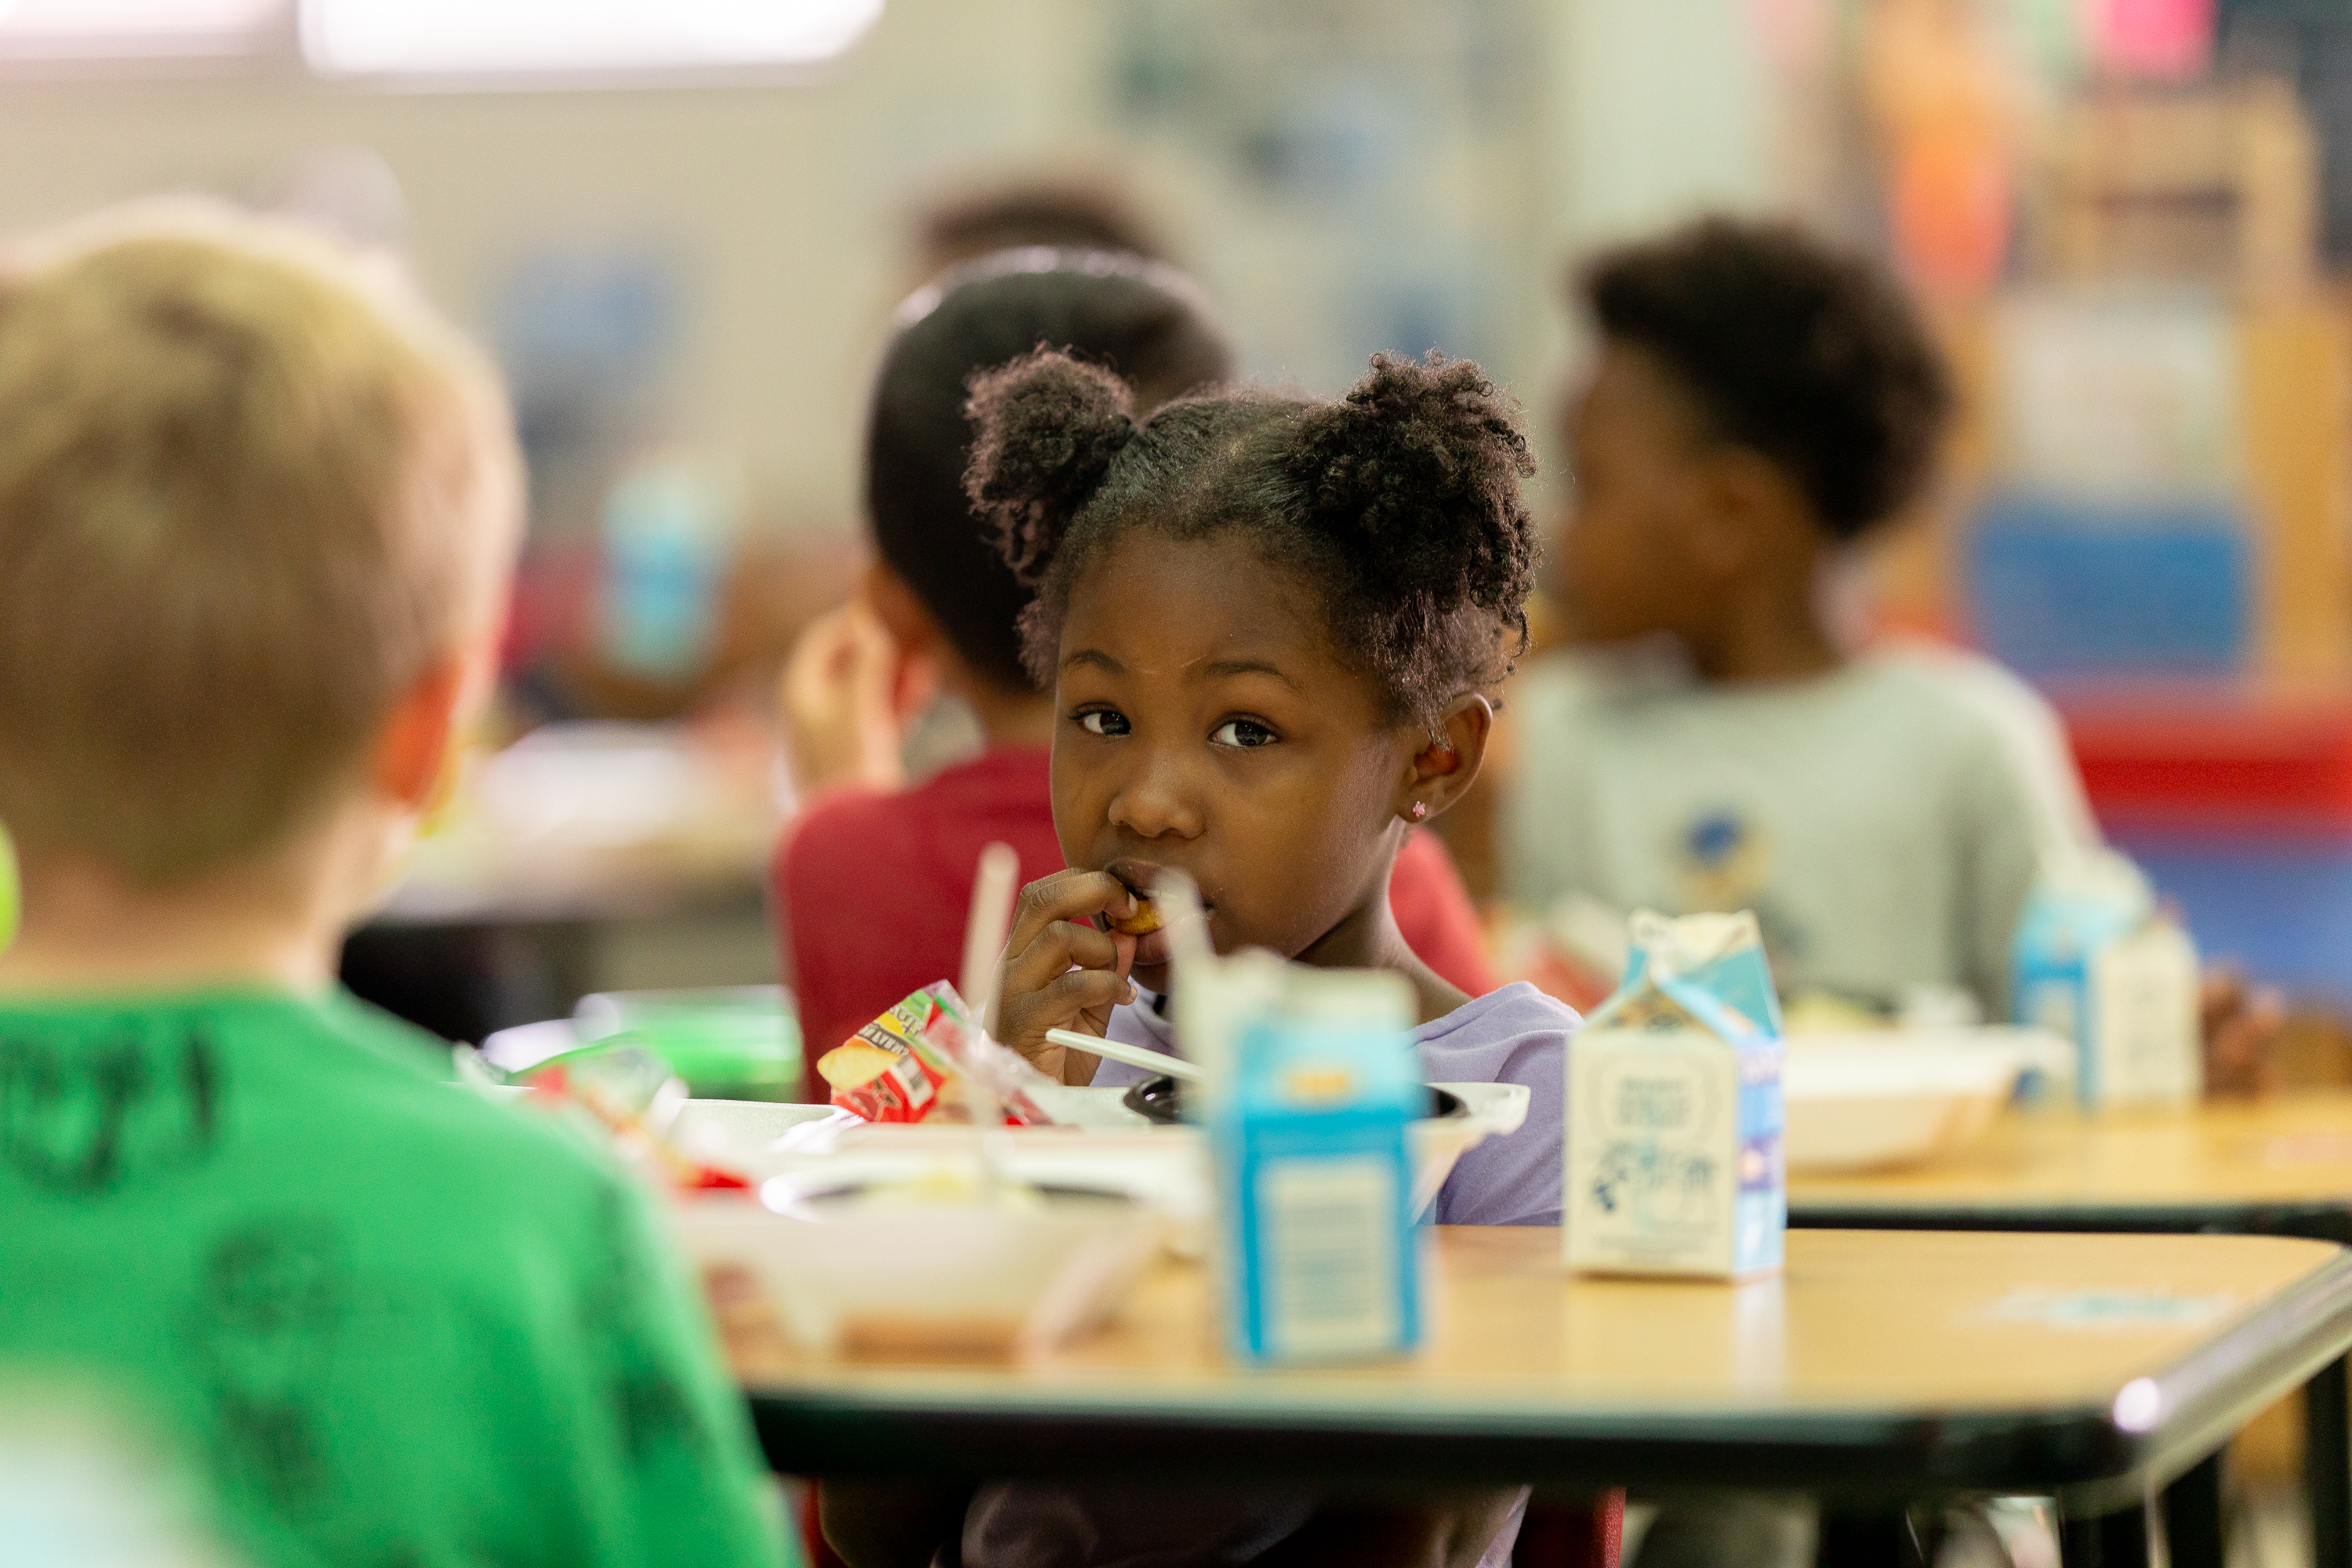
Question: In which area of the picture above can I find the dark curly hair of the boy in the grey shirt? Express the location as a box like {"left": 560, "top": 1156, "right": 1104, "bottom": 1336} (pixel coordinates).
{"left": 1581, "top": 219, "right": 1952, "bottom": 539}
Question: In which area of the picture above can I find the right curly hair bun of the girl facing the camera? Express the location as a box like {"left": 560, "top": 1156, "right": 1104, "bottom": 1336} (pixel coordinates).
{"left": 1291, "top": 353, "right": 1536, "bottom": 628}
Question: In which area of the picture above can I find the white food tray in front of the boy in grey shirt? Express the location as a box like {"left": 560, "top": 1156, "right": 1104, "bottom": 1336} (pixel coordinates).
{"left": 1780, "top": 1027, "right": 2051, "bottom": 1173}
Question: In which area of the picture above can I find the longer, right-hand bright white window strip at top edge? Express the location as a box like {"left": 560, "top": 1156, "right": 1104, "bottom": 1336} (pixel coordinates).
{"left": 296, "top": 0, "right": 882, "bottom": 78}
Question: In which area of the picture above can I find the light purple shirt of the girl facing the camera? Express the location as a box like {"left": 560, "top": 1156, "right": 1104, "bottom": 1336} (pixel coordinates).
{"left": 1094, "top": 980, "right": 1581, "bottom": 1225}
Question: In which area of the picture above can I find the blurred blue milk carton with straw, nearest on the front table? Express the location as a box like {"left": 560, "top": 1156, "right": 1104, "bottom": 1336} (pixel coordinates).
{"left": 1223, "top": 968, "right": 1428, "bottom": 1363}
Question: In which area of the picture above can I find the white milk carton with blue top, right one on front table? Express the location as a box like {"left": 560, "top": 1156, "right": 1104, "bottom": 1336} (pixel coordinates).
{"left": 1562, "top": 914, "right": 1788, "bottom": 1279}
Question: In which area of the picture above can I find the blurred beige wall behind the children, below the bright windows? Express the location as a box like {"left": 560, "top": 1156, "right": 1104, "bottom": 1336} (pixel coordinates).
{"left": 0, "top": 0, "right": 1769, "bottom": 529}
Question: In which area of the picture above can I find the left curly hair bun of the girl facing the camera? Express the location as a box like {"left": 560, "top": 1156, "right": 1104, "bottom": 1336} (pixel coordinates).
{"left": 964, "top": 348, "right": 1136, "bottom": 583}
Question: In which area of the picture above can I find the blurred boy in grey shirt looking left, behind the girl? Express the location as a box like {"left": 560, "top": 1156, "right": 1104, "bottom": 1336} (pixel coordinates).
{"left": 1498, "top": 219, "right": 2277, "bottom": 1086}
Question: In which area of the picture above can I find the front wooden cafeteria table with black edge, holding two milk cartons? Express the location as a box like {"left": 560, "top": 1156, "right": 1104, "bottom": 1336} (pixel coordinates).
{"left": 739, "top": 1227, "right": 2352, "bottom": 1568}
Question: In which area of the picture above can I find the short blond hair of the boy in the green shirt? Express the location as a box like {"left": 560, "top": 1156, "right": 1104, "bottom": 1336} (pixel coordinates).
{"left": 0, "top": 207, "right": 520, "bottom": 886}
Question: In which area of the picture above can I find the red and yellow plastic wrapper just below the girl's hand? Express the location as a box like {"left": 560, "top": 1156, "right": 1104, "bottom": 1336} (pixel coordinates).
{"left": 816, "top": 980, "right": 1051, "bottom": 1126}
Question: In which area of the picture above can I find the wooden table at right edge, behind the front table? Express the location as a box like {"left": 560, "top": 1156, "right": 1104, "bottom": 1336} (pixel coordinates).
{"left": 1788, "top": 1091, "right": 2352, "bottom": 1568}
